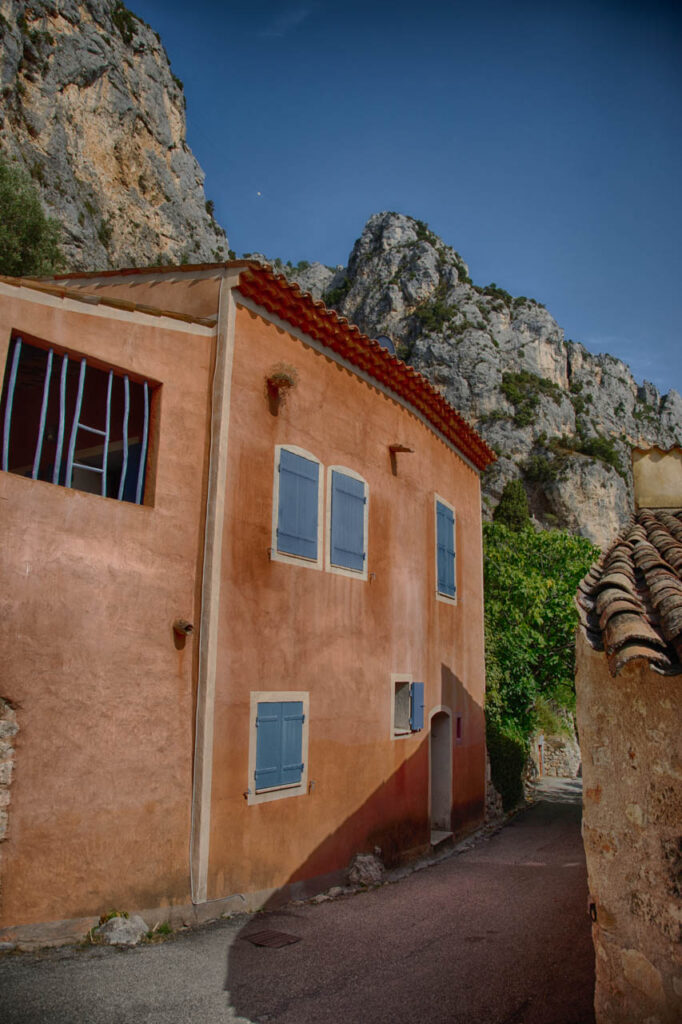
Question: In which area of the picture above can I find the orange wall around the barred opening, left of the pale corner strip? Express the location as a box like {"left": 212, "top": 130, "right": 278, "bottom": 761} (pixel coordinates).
{"left": 0, "top": 291, "right": 214, "bottom": 926}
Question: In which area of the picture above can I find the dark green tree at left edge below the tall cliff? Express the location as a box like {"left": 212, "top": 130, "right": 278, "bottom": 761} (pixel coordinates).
{"left": 0, "top": 160, "right": 65, "bottom": 278}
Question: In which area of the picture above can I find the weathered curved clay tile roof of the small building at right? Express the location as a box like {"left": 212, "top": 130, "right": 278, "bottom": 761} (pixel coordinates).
{"left": 577, "top": 509, "right": 682, "bottom": 676}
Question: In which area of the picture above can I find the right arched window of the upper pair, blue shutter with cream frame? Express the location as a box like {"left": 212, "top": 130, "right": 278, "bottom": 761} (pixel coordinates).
{"left": 328, "top": 467, "right": 368, "bottom": 580}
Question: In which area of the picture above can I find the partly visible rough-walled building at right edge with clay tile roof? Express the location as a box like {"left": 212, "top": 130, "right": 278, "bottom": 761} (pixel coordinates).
{"left": 576, "top": 450, "right": 682, "bottom": 1024}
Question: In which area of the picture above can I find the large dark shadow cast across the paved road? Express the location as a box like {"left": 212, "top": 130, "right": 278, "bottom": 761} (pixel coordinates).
{"left": 226, "top": 779, "right": 594, "bottom": 1024}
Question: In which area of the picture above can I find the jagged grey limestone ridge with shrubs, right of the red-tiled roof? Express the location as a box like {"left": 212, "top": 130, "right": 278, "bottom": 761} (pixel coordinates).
{"left": 290, "top": 213, "right": 682, "bottom": 546}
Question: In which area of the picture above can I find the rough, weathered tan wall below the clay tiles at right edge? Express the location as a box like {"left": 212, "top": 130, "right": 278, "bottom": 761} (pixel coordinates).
{"left": 576, "top": 631, "right": 682, "bottom": 1024}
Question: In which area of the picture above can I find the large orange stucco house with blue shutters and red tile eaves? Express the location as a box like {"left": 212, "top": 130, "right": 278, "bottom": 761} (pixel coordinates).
{"left": 0, "top": 261, "right": 494, "bottom": 938}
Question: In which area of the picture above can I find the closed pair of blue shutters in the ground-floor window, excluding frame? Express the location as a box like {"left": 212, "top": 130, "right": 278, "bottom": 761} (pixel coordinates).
{"left": 251, "top": 700, "right": 304, "bottom": 790}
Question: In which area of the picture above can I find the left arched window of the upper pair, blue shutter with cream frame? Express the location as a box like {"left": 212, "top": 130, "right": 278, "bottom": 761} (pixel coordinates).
{"left": 271, "top": 446, "right": 322, "bottom": 568}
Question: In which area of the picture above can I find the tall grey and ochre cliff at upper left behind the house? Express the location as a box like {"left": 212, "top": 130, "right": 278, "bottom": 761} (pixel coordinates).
{"left": 0, "top": 0, "right": 227, "bottom": 269}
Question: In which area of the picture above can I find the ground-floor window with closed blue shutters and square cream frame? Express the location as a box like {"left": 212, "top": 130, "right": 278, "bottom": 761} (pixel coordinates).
{"left": 246, "top": 691, "right": 308, "bottom": 804}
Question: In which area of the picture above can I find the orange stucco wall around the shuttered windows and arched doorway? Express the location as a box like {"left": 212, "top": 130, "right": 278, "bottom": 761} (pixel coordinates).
{"left": 209, "top": 308, "right": 484, "bottom": 897}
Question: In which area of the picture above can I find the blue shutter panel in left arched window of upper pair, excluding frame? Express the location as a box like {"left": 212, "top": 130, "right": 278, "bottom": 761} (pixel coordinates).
{"left": 278, "top": 449, "right": 319, "bottom": 559}
